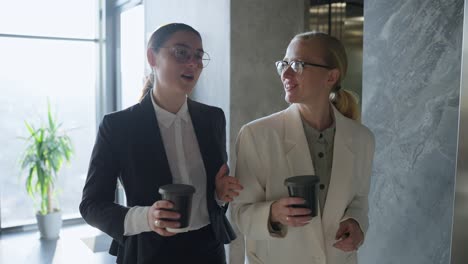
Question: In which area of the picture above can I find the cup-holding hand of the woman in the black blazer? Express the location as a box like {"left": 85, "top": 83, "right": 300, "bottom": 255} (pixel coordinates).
{"left": 147, "top": 200, "right": 180, "bottom": 236}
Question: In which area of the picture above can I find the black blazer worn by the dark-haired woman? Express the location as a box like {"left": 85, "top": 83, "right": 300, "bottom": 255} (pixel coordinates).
{"left": 80, "top": 93, "right": 235, "bottom": 263}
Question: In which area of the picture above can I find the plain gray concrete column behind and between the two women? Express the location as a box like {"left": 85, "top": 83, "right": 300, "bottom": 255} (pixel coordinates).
{"left": 228, "top": 0, "right": 308, "bottom": 264}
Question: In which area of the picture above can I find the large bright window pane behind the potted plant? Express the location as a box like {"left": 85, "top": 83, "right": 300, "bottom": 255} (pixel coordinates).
{"left": 0, "top": 0, "right": 99, "bottom": 228}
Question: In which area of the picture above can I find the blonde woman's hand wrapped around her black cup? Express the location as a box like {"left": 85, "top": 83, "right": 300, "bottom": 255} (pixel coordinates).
{"left": 270, "top": 197, "right": 312, "bottom": 226}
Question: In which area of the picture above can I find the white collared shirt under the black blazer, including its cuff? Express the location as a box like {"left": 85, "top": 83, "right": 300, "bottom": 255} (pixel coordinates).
{"left": 124, "top": 96, "right": 210, "bottom": 236}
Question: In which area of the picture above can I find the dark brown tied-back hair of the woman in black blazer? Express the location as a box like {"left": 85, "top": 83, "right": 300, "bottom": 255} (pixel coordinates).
{"left": 140, "top": 23, "right": 201, "bottom": 101}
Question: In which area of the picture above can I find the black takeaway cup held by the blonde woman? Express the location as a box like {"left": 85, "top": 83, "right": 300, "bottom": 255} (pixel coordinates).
{"left": 284, "top": 175, "right": 320, "bottom": 217}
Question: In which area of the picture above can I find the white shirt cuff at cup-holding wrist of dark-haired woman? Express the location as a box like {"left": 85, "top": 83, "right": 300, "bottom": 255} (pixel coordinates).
{"left": 124, "top": 206, "right": 151, "bottom": 236}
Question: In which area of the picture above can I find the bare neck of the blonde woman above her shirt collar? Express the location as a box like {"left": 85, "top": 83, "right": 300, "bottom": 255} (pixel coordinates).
{"left": 298, "top": 102, "right": 333, "bottom": 131}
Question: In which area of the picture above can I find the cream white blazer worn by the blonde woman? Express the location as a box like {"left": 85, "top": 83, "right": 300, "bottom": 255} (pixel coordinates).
{"left": 231, "top": 104, "right": 375, "bottom": 264}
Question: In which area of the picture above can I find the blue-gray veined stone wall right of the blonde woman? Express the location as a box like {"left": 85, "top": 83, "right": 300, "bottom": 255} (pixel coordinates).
{"left": 359, "top": 0, "right": 463, "bottom": 264}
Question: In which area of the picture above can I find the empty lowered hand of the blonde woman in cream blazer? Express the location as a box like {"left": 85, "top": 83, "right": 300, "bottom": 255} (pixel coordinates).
{"left": 333, "top": 218, "right": 364, "bottom": 252}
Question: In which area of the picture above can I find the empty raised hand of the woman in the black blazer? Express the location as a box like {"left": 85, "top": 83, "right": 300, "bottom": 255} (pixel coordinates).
{"left": 215, "top": 164, "right": 244, "bottom": 202}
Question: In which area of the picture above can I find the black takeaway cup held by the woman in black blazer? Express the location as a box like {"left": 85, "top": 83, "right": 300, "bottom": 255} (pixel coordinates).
{"left": 159, "top": 184, "right": 195, "bottom": 233}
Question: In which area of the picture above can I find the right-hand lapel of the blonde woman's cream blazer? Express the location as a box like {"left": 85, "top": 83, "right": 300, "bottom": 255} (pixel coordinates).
{"left": 322, "top": 107, "right": 354, "bottom": 232}
